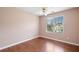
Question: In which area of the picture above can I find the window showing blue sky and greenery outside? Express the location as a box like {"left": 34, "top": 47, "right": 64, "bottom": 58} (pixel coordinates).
{"left": 47, "top": 16, "right": 64, "bottom": 32}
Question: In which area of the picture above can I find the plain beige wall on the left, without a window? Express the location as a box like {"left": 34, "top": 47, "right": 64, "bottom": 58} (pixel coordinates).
{"left": 0, "top": 7, "right": 39, "bottom": 48}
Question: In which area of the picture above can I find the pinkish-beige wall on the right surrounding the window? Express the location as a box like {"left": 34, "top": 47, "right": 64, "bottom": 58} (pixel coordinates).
{"left": 39, "top": 8, "right": 79, "bottom": 44}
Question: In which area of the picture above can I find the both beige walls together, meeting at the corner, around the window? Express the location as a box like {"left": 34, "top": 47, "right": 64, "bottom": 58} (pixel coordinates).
{"left": 0, "top": 7, "right": 79, "bottom": 48}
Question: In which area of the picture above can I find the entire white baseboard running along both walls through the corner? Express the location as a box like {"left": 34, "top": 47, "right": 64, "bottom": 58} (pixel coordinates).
{"left": 0, "top": 36, "right": 79, "bottom": 50}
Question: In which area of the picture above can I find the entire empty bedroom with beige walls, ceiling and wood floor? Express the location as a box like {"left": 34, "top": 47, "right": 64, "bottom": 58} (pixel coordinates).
{"left": 0, "top": 7, "right": 79, "bottom": 52}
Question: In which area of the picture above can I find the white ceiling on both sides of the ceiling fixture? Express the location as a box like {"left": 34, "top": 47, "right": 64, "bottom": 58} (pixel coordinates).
{"left": 17, "top": 7, "right": 72, "bottom": 16}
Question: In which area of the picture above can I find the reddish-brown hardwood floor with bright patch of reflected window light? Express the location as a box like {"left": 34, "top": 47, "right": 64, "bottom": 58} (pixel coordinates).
{"left": 1, "top": 37, "right": 79, "bottom": 52}
